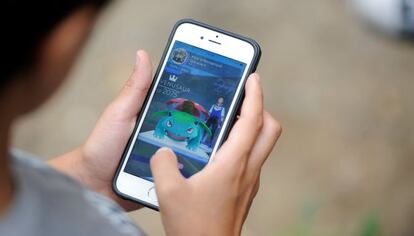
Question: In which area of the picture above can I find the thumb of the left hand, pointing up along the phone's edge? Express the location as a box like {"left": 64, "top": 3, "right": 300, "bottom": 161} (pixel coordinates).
{"left": 111, "top": 50, "right": 152, "bottom": 120}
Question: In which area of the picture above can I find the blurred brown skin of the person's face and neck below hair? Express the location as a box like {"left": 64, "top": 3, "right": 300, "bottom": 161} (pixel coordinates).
{"left": 0, "top": 7, "right": 96, "bottom": 214}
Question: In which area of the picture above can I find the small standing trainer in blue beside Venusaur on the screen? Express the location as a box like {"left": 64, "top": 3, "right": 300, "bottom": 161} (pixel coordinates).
{"left": 206, "top": 97, "right": 226, "bottom": 147}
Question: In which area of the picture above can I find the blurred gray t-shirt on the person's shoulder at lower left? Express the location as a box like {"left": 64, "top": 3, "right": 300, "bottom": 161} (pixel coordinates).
{"left": 0, "top": 150, "right": 144, "bottom": 236}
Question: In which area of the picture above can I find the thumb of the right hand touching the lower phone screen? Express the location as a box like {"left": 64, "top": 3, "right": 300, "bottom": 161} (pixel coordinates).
{"left": 150, "top": 147, "right": 184, "bottom": 192}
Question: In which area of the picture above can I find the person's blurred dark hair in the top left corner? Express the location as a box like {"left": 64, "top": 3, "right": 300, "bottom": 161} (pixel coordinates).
{"left": 0, "top": 0, "right": 109, "bottom": 89}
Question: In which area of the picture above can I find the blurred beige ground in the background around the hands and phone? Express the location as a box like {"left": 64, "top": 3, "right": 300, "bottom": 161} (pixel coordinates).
{"left": 13, "top": 0, "right": 414, "bottom": 236}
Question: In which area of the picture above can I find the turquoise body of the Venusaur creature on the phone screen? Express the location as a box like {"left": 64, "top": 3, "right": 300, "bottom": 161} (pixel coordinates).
{"left": 153, "top": 111, "right": 211, "bottom": 150}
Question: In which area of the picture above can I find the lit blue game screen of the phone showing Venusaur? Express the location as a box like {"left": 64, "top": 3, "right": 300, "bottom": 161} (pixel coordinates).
{"left": 124, "top": 41, "right": 246, "bottom": 181}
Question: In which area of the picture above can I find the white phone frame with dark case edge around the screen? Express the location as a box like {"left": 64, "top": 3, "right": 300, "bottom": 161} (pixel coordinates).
{"left": 113, "top": 19, "right": 261, "bottom": 210}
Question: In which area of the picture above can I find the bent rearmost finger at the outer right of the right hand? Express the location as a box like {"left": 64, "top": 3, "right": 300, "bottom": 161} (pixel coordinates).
{"left": 247, "top": 111, "right": 282, "bottom": 171}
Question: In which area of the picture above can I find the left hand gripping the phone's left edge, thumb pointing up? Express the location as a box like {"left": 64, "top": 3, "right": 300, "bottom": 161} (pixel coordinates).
{"left": 50, "top": 51, "right": 152, "bottom": 210}
